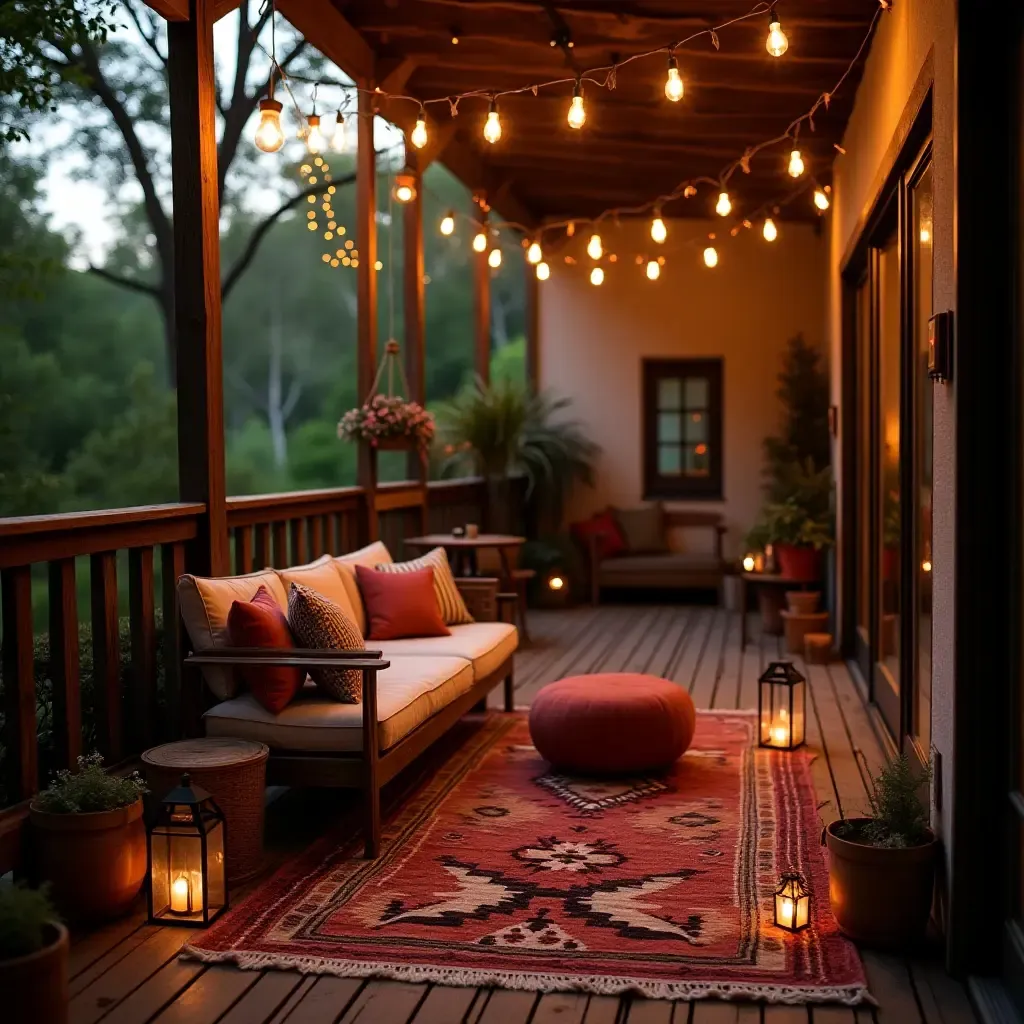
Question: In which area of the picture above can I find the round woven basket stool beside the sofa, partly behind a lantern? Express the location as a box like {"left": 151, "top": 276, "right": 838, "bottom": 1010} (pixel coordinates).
{"left": 142, "top": 736, "right": 270, "bottom": 883}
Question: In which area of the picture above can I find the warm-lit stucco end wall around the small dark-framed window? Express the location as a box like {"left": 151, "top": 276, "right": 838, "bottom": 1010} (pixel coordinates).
{"left": 540, "top": 219, "right": 828, "bottom": 553}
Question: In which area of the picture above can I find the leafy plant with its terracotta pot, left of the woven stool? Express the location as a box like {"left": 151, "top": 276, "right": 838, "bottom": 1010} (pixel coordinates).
{"left": 29, "top": 754, "right": 146, "bottom": 921}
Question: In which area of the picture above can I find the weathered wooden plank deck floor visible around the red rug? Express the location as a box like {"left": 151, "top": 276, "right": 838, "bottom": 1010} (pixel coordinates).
{"left": 71, "top": 605, "right": 975, "bottom": 1024}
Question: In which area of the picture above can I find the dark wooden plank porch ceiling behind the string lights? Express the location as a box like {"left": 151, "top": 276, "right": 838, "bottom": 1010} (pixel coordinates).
{"left": 325, "top": 0, "right": 878, "bottom": 220}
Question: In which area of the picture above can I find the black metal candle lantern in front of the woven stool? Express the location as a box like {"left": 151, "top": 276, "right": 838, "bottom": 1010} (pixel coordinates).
{"left": 146, "top": 775, "right": 227, "bottom": 928}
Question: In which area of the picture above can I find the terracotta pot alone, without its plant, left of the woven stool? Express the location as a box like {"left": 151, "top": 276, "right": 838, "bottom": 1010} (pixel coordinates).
{"left": 30, "top": 800, "right": 146, "bottom": 922}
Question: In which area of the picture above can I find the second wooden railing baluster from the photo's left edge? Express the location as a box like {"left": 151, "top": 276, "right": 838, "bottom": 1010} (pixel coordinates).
{"left": 49, "top": 558, "right": 82, "bottom": 767}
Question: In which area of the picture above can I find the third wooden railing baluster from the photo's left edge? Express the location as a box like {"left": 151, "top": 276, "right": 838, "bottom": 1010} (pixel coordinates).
{"left": 89, "top": 551, "right": 124, "bottom": 761}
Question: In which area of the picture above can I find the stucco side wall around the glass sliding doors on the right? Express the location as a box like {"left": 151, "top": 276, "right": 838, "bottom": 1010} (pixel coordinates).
{"left": 829, "top": 0, "right": 955, "bottom": 860}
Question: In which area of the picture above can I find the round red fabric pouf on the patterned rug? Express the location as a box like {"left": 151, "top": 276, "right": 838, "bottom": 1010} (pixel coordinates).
{"left": 529, "top": 672, "right": 696, "bottom": 775}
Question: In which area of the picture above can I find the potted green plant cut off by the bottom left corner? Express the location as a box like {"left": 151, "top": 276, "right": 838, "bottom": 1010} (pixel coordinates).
{"left": 0, "top": 885, "right": 68, "bottom": 1024}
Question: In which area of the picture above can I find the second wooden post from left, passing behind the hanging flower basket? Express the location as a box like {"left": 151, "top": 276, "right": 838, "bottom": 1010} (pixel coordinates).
{"left": 355, "top": 86, "right": 380, "bottom": 543}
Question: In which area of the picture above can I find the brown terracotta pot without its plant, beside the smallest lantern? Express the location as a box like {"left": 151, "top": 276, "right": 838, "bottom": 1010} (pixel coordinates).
{"left": 825, "top": 818, "right": 937, "bottom": 948}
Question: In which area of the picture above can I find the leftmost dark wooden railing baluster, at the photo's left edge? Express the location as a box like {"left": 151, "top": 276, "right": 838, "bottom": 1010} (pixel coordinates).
{"left": 0, "top": 565, "right": 39, "bottom": 802}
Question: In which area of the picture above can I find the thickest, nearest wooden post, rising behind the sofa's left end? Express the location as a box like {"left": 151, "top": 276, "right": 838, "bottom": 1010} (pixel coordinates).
{"left": 167, "top": 0, "right": 229, "bottom": 574}
